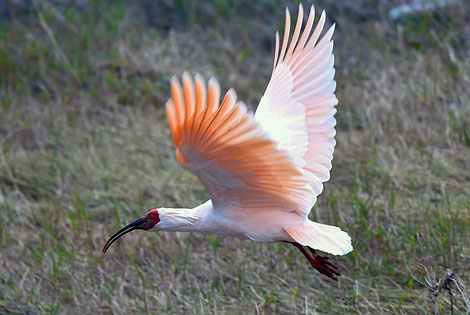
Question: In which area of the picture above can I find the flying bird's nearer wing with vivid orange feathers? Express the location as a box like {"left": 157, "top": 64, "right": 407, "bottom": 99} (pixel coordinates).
{"left": 166, "top": 73, "right": 314, "bottom": 211}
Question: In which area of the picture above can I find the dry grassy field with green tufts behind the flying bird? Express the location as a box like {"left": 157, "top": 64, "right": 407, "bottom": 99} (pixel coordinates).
{"left": 0, "top": 0, "right": 470, "bottom": 314}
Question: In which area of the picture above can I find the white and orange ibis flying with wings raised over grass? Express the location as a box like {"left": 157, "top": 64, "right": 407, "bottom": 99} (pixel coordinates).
{"left": 102, "top": 4, "right": 353, "bottom": 281}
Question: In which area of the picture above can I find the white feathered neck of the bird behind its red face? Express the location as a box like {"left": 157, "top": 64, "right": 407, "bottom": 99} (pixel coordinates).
{"left": 152, "top": 200, "right": 212, "bottom": 232}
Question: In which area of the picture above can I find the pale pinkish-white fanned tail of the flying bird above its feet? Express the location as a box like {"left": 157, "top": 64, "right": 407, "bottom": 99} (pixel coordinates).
{"left": 286, "top": 221, "right": 353, "bottom": 255}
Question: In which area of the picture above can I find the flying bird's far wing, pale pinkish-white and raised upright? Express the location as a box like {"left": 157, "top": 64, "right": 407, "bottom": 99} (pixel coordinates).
{"left": 255, "top": 5, "right": 338, "bottom": 214}
